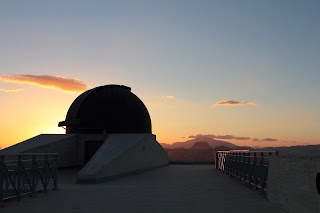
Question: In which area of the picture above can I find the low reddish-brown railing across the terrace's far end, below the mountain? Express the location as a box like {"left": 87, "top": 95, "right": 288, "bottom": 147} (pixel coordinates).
{"left": 166, "top": 149, "right": 214, "bottom": 164}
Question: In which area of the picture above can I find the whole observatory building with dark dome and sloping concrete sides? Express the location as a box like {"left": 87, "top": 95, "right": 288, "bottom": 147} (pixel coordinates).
{"left": 4, "top": 85, "right": 168, "bottom": 183}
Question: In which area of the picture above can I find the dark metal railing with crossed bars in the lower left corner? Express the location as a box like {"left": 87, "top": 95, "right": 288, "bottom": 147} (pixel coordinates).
{"left": 0, "top": 153, "right": 58, "bottom": 205}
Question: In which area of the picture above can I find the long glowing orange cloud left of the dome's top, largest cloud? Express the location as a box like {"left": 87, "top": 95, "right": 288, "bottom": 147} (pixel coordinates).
{"left": 0, "top": 75, "right": 89, "bottom": 92}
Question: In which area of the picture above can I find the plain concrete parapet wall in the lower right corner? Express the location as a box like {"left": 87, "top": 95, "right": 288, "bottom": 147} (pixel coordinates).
{"left": 267, "top": 157, "right": 320, "bottom": 213}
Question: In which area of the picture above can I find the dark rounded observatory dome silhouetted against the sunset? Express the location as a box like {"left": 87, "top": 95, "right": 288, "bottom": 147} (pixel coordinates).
{"left": 58, "top": 85, "right": 151, "bottom": 134}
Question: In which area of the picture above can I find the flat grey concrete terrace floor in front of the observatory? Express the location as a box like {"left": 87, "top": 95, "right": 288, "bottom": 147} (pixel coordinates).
{"left": 0, "top": 164, "right": 285, "bottom": 213}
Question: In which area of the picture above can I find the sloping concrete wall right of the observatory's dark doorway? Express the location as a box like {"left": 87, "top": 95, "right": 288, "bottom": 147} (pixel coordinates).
{"left": 78, "top": 134, "right": 168, "bottom": 183}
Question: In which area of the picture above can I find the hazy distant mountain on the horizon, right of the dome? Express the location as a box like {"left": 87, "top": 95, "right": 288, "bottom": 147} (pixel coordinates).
{"left": 161, "top": 137, "right": 239, "bottom": 149}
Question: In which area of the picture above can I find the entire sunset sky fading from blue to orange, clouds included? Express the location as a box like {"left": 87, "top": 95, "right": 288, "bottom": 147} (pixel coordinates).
{"left": 0, "top": 0, "right": 320, "bottom": 148}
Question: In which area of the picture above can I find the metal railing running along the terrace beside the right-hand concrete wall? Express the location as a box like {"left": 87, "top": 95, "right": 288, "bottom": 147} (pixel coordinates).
{"left": 215, "top": 150, "right": 278, "bottom": 192}
